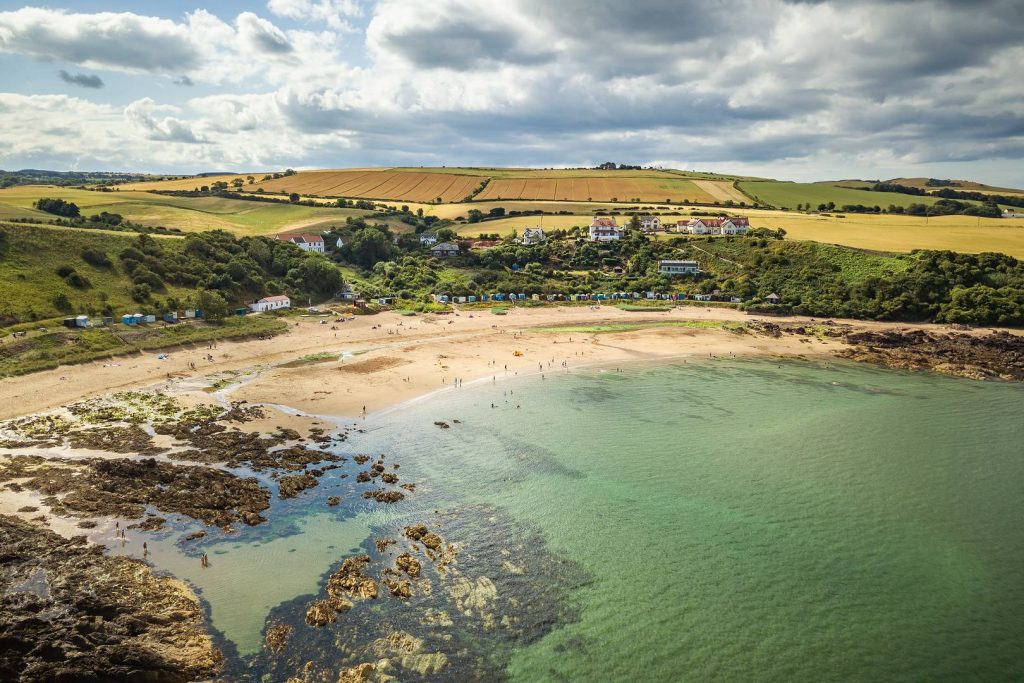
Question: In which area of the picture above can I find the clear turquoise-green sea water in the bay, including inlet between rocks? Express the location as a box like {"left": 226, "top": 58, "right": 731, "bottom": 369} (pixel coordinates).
{"left": 112, "top": 359, "right": 1024, "bottom": 681}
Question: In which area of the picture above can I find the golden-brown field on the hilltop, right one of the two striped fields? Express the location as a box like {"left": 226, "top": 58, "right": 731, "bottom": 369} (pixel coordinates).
{"left": 474, "top": 172, "right": 720, "bottom": 204}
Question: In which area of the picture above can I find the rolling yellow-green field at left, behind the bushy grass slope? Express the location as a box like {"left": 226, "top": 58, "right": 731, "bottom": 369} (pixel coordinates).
{"left": 0, "top": 185, "right": 369, "bottom": 234}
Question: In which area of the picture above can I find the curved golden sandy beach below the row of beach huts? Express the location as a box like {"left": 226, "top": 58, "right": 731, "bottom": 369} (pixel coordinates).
{"left": 0, "top": 306, "right": 982, "bottom": 419}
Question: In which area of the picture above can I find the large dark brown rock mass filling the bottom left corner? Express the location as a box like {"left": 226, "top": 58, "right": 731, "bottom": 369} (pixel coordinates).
{"left": 0, "top": 516, "right": 222, "bottom": 683}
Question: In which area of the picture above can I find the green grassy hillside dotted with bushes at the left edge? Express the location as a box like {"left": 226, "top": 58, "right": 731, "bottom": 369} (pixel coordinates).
{"left": 0, "top": 223, "right": 188, "bottom": 319}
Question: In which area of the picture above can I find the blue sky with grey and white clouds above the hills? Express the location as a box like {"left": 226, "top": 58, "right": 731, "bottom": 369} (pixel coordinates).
{"left": 0, "top": 0, "right": 1024, "bottom": 187}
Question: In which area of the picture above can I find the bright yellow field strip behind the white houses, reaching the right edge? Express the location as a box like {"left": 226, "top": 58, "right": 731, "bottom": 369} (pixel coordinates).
{"left": 459, "top": 210, "right": 1024, "bottom": 258}
